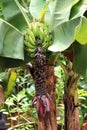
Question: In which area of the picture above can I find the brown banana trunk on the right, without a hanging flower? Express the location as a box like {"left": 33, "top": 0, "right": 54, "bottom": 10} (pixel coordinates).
{"left": 64, "top": 61, "right": 80, "bottom": 130}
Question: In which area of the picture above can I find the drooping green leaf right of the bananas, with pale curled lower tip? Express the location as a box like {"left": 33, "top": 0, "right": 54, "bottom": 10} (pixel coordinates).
{"left": 48, "top": 18, "right": 80, "bottom": 52}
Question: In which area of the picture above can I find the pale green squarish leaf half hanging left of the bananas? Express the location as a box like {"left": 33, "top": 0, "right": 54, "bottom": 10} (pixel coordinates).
{"left": 0, "top": 19, "right": 24, "bottom": 60}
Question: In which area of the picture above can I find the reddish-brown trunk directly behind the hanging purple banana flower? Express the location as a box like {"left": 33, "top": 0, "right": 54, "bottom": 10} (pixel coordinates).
{"left": 38, "top": 66, "right": 57, "bottom": 130}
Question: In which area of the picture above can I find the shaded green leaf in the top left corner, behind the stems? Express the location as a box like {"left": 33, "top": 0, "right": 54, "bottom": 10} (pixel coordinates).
{"left": 0, "top": 0, "right": 27, "bottom": 30}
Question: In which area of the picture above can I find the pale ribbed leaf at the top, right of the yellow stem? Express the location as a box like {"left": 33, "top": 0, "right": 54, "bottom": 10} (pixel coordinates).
{"left": 51, "top": 0, "right": 78, "bottom": 30}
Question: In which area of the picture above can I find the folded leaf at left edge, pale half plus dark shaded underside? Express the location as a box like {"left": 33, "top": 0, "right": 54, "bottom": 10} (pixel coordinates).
{"left": 0, "top": 19, "right": 31, "bottom": 68}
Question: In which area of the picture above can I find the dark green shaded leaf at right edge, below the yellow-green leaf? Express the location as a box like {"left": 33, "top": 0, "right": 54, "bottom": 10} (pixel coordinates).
{"left": 73, "top": 42, "right": 87, "bottom": 76}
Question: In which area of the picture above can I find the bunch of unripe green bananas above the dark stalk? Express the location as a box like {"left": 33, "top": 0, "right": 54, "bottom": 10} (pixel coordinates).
{"left": 24, "top": 22, "right": 52, "bottom": 57}
